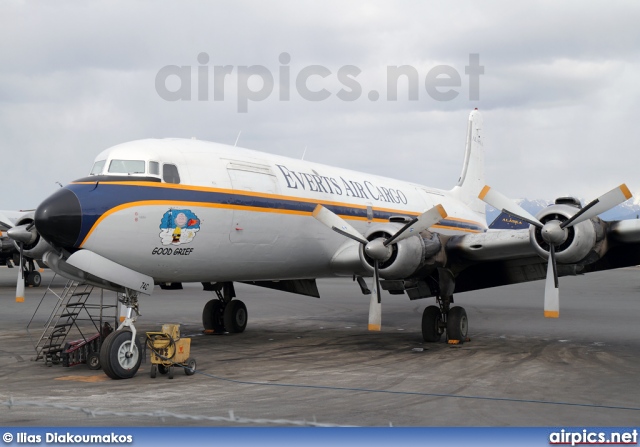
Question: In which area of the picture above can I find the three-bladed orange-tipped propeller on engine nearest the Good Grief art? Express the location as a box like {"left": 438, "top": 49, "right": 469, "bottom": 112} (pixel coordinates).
{"left": 313, "top": 205, "right": 447, "bottom": 331}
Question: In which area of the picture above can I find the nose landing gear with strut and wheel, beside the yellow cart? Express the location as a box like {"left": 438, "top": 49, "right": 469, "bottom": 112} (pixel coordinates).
{"left": 100, "top": 289, "right": 142, "bottom": 380}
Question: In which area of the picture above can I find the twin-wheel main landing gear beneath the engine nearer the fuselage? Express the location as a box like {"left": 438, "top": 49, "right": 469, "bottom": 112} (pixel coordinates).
{"left": 422, "top": 295, "right": 469, "bottom": 344}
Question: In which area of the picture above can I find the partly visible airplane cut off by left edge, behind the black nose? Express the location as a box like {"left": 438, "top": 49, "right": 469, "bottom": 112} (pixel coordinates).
{"left": 0, "top": 211, "right": 42, "bottom": 294}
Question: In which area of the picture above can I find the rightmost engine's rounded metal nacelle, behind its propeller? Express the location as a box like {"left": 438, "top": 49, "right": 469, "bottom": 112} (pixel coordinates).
{"left": 529, "top": 204, "right": 604, "bottom": 264}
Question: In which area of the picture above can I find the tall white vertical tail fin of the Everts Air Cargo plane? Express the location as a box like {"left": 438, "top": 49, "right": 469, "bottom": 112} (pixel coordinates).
{"left": 451, "top": 109, "right": 485, "bottom": 216}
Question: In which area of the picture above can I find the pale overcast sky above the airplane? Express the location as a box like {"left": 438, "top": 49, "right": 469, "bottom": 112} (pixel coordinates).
{"left": 0, "top": 0, "right": 640, "bottom": 209}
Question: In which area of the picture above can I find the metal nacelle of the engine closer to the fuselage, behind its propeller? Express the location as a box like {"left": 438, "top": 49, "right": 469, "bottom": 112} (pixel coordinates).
{"left": 360, "top": 222, "right": 442, "bottom": 279}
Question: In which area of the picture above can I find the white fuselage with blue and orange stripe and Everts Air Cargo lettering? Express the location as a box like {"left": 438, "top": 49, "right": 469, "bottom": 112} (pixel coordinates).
{"left": 67, "top": 139, "right": 486, "bottom": 282}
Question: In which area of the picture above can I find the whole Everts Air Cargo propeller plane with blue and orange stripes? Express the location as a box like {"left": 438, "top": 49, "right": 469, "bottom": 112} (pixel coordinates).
{"left": 10, "top": 110, "right": 640, "bottom": 379}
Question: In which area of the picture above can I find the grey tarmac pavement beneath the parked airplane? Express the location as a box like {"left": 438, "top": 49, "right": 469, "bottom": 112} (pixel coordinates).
{"left": 0, "top": 268, "right": 640, "bottom": 427}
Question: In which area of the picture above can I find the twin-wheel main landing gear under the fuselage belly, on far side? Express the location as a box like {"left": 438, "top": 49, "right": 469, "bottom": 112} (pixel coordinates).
{"left": 202, "top": 282, "right": 248, "bottom": 334}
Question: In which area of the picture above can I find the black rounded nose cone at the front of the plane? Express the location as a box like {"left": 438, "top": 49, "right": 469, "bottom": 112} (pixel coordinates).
{"left": 34, "top": 188, "right": 82, "bottom": 250}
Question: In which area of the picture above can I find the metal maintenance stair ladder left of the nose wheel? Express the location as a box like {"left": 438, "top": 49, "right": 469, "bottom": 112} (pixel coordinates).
{"left": 27, "top": 275, "right": 118, "bottom": 366}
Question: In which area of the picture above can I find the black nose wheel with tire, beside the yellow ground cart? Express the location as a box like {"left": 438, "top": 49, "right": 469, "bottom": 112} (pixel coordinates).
{"left": 100, "top": 329, "right": 142, "bottom": 380}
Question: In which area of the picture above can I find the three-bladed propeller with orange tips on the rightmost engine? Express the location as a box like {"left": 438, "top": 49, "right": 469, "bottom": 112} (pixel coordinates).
{"left": 478, "top": 183, "right": 631, "bottom": 318}
